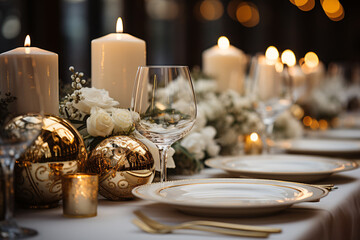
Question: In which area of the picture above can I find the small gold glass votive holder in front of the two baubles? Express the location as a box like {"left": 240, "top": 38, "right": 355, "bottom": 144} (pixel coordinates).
{"left": 62, "top": 173, "right": 99, "bottom": 218}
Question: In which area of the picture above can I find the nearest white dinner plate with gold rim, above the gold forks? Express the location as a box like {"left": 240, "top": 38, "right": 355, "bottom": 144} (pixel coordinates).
{"left": 132, "top": 178, "right": 328, "bottom": 217}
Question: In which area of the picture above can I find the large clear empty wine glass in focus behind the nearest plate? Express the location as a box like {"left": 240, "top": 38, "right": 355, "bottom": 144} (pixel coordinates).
{"left": 131, "top": 66, "right": 197, "bottom": 182}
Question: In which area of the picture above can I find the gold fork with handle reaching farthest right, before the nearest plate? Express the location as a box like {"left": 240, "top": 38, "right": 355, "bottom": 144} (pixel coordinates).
{"left": 134, "top": 210, "right": 281, "bottom": 233}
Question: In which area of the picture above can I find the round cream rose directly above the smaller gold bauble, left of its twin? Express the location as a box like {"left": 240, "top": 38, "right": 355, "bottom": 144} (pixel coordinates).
{"left": 86, "top": 107, "right": 114, "bottom": 137}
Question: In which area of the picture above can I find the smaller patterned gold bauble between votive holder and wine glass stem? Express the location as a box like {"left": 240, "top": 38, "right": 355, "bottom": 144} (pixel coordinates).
{"left": 85, "top": 136, "right": 155, "bottom": 201}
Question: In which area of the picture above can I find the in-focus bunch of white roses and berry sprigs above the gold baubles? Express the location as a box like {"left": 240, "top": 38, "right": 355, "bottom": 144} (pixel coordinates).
{"left": 60, "top": 67, "right": 134, "bottom": 150}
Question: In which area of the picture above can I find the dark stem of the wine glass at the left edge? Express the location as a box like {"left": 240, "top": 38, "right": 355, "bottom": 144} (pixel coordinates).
{"left": 1, "top": 157, "right": 15, "bottom": 222}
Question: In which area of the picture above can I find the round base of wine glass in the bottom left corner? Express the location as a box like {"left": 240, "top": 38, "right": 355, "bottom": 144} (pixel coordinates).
{"left": 0, "top": 222, "right": 38, "bottom": 239}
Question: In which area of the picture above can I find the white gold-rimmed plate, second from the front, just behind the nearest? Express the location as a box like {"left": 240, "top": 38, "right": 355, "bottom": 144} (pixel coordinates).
{"left": 205, "top": 155, "right": 358, "bottom": 182}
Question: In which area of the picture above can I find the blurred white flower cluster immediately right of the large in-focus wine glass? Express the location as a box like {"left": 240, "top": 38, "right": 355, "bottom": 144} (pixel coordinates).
{"left": 173, "top": 79, "right": 263, "bottom": 160}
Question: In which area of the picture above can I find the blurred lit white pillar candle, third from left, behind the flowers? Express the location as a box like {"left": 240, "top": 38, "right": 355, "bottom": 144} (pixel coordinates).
{"left": 202, "top": 37, "right": 246, "bottom": 93}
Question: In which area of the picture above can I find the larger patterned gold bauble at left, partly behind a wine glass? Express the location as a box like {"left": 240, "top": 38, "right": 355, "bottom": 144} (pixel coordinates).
{"left": 15, "top": 115, "right": 87, "bottom": 208}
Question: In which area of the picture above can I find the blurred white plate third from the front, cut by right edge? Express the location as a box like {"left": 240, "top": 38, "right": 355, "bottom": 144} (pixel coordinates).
{"left": 280, "top": 139, "right": 360, "bottom": 156}
